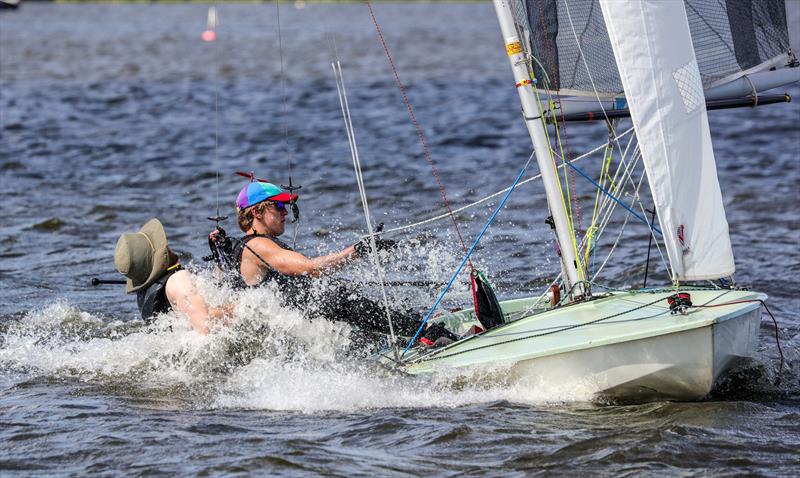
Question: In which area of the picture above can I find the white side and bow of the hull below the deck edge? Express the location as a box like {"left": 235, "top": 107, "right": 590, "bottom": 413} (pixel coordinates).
{"left": 511, "top": 309, "right": 761, "bottom": 402}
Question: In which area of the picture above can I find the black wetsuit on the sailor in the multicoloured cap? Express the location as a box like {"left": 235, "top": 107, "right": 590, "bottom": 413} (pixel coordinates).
{"left": 233, "top": 234, "right": 421, "bottom": 336}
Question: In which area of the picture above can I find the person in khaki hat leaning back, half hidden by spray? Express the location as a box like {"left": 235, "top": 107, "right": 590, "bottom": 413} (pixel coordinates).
{"left": 114, "top": 218, "right": 229, "bottom": 335}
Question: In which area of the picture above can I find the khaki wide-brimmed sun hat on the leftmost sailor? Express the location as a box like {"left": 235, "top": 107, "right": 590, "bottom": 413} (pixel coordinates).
{"left": 114, "top": 218, "right": 169, "bottom": 293}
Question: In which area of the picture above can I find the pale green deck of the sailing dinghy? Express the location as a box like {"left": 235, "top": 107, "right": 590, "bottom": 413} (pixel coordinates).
{"left": 390, "top": 289, "right": 766, "bottom": 373}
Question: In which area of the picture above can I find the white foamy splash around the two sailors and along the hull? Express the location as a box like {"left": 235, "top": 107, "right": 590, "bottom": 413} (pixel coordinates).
{"left": 0, "top": 257, "right": 590, "bottom": 413}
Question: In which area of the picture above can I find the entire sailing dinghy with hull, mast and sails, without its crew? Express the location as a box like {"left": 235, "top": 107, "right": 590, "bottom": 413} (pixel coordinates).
{"left": 374, "top": 0, "right": 800, "bottom": 401}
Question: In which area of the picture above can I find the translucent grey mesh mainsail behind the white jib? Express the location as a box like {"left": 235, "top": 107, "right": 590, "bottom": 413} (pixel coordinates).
{"left": 525, "top": 0, "right": 793, "bottom": 98}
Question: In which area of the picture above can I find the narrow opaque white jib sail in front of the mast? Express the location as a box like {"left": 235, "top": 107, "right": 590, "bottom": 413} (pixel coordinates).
{"left": 600, "top": 0, "right": 735, "bottom": 280}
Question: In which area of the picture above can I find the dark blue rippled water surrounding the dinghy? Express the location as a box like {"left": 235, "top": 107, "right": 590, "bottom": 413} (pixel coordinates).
{"left": 0, "top": 3, "right": 800, "bottom": 476}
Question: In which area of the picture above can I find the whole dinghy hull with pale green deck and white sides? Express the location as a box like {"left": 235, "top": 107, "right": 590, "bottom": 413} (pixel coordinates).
{"left": 382, "top": 290, "right": 766, "bottom": 402}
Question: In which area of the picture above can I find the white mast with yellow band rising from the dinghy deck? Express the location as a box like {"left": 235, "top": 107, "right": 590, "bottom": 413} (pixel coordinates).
{"left": 493, "top": 0, "right": 584, "bottom": 296}
